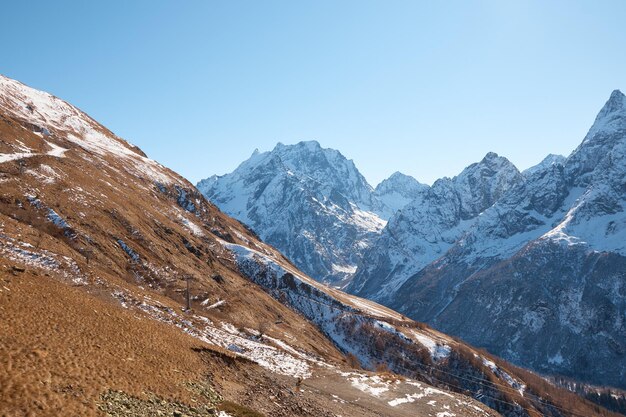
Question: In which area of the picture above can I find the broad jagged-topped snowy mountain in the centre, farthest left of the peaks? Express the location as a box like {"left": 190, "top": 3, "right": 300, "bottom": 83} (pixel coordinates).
{"left": 198, "top": 141, "right": 416, "bottom": 285}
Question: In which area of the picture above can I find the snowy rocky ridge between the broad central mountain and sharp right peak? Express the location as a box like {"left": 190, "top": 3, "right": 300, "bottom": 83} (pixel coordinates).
{"left": 349, "top": 153, "right": 524, "bottom": 302}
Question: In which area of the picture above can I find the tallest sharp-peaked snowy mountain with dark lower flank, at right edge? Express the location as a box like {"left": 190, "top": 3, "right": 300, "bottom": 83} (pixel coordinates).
{"left": 353, "top": 91, "right": 626, "bottom": 387}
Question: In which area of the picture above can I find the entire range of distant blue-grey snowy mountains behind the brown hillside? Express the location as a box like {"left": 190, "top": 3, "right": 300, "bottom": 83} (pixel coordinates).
{"left": 198, "top": 90, "right": 626, "bottom": 388}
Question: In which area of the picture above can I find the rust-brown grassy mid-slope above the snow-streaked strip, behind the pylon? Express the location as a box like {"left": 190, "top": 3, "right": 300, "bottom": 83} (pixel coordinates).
{"left": 0, "top": 110, "right": 343, "bottom": 361}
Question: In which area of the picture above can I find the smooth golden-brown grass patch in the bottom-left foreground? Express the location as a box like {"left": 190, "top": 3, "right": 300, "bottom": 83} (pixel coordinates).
{"left": 0, "top": 266, "right": 210, "bottom": 416}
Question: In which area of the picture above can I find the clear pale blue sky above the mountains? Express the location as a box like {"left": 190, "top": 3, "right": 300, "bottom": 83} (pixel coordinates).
{"left": 0, "top": 0, "right": 626, "bottom": 185}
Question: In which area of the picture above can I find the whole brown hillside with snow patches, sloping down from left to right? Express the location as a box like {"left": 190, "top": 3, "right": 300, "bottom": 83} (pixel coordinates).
{"left": 0, "top": 77, "right": 610, "bottom": 417}
